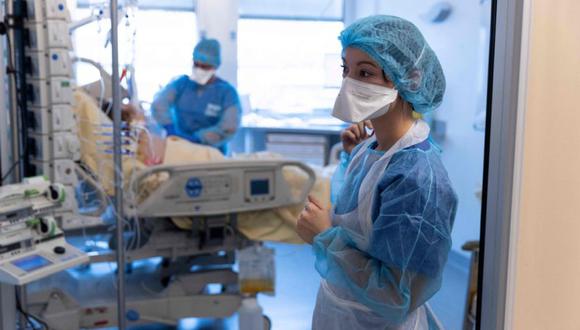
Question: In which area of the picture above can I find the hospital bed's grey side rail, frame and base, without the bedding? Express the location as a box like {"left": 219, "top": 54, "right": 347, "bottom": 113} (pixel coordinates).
{"left": 28, "top": 160, "right": 315, "bottom": 330}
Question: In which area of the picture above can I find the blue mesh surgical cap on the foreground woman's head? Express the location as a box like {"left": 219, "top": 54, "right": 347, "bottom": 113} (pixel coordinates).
{"left": 339, "top": 15, "right": 445, "bottom": 113}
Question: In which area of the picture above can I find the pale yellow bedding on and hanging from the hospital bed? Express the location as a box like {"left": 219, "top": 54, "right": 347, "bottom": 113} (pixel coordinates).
{"left": 75, "top": 91, "right": 331, "bottom": 243}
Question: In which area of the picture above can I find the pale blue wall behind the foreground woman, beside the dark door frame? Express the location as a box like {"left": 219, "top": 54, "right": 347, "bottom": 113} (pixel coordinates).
{"left": 347, "top": 0, "right": 491, "bottom": 253}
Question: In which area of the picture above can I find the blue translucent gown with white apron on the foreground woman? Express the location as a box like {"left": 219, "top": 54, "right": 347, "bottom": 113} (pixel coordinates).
{"left": 313, "top": 123, "right": 457, "bottom": 329}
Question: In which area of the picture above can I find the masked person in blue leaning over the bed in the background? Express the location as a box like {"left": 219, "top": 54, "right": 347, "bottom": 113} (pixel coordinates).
{"left": 151, "top": 39, "right": 241, "bottom": 154}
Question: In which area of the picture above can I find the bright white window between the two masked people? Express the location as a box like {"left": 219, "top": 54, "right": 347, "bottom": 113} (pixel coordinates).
{"left": 238, "top": 19, "right": 344, "bottom": 114}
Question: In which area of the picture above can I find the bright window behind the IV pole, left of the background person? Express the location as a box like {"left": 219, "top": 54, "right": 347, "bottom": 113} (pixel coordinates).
{"left": 73, "top": 8, "right": 197, "bottom": 101}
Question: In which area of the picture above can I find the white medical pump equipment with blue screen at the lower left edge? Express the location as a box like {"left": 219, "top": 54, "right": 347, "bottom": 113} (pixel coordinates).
{"left": 0, "top": 177, "right": 89, "bottom": 285}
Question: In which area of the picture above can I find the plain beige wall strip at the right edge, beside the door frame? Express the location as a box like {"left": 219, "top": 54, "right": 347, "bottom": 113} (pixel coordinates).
{"left": 506, "top": 0, "right": 580, "bottom": 330}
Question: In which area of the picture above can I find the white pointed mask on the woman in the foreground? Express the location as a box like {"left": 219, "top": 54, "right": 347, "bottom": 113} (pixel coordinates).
{"left": 332, "top": 77, "right": 398, "bottom": 123}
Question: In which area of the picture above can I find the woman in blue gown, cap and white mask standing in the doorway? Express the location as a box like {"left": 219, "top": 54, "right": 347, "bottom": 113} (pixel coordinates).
{"left": 296, "top": 16, "right": 457, "bottom": 330}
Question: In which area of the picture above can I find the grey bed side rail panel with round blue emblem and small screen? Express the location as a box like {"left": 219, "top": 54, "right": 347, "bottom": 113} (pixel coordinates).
{"left": 130, "top": 160, "right": 315, "bottom": 217}
